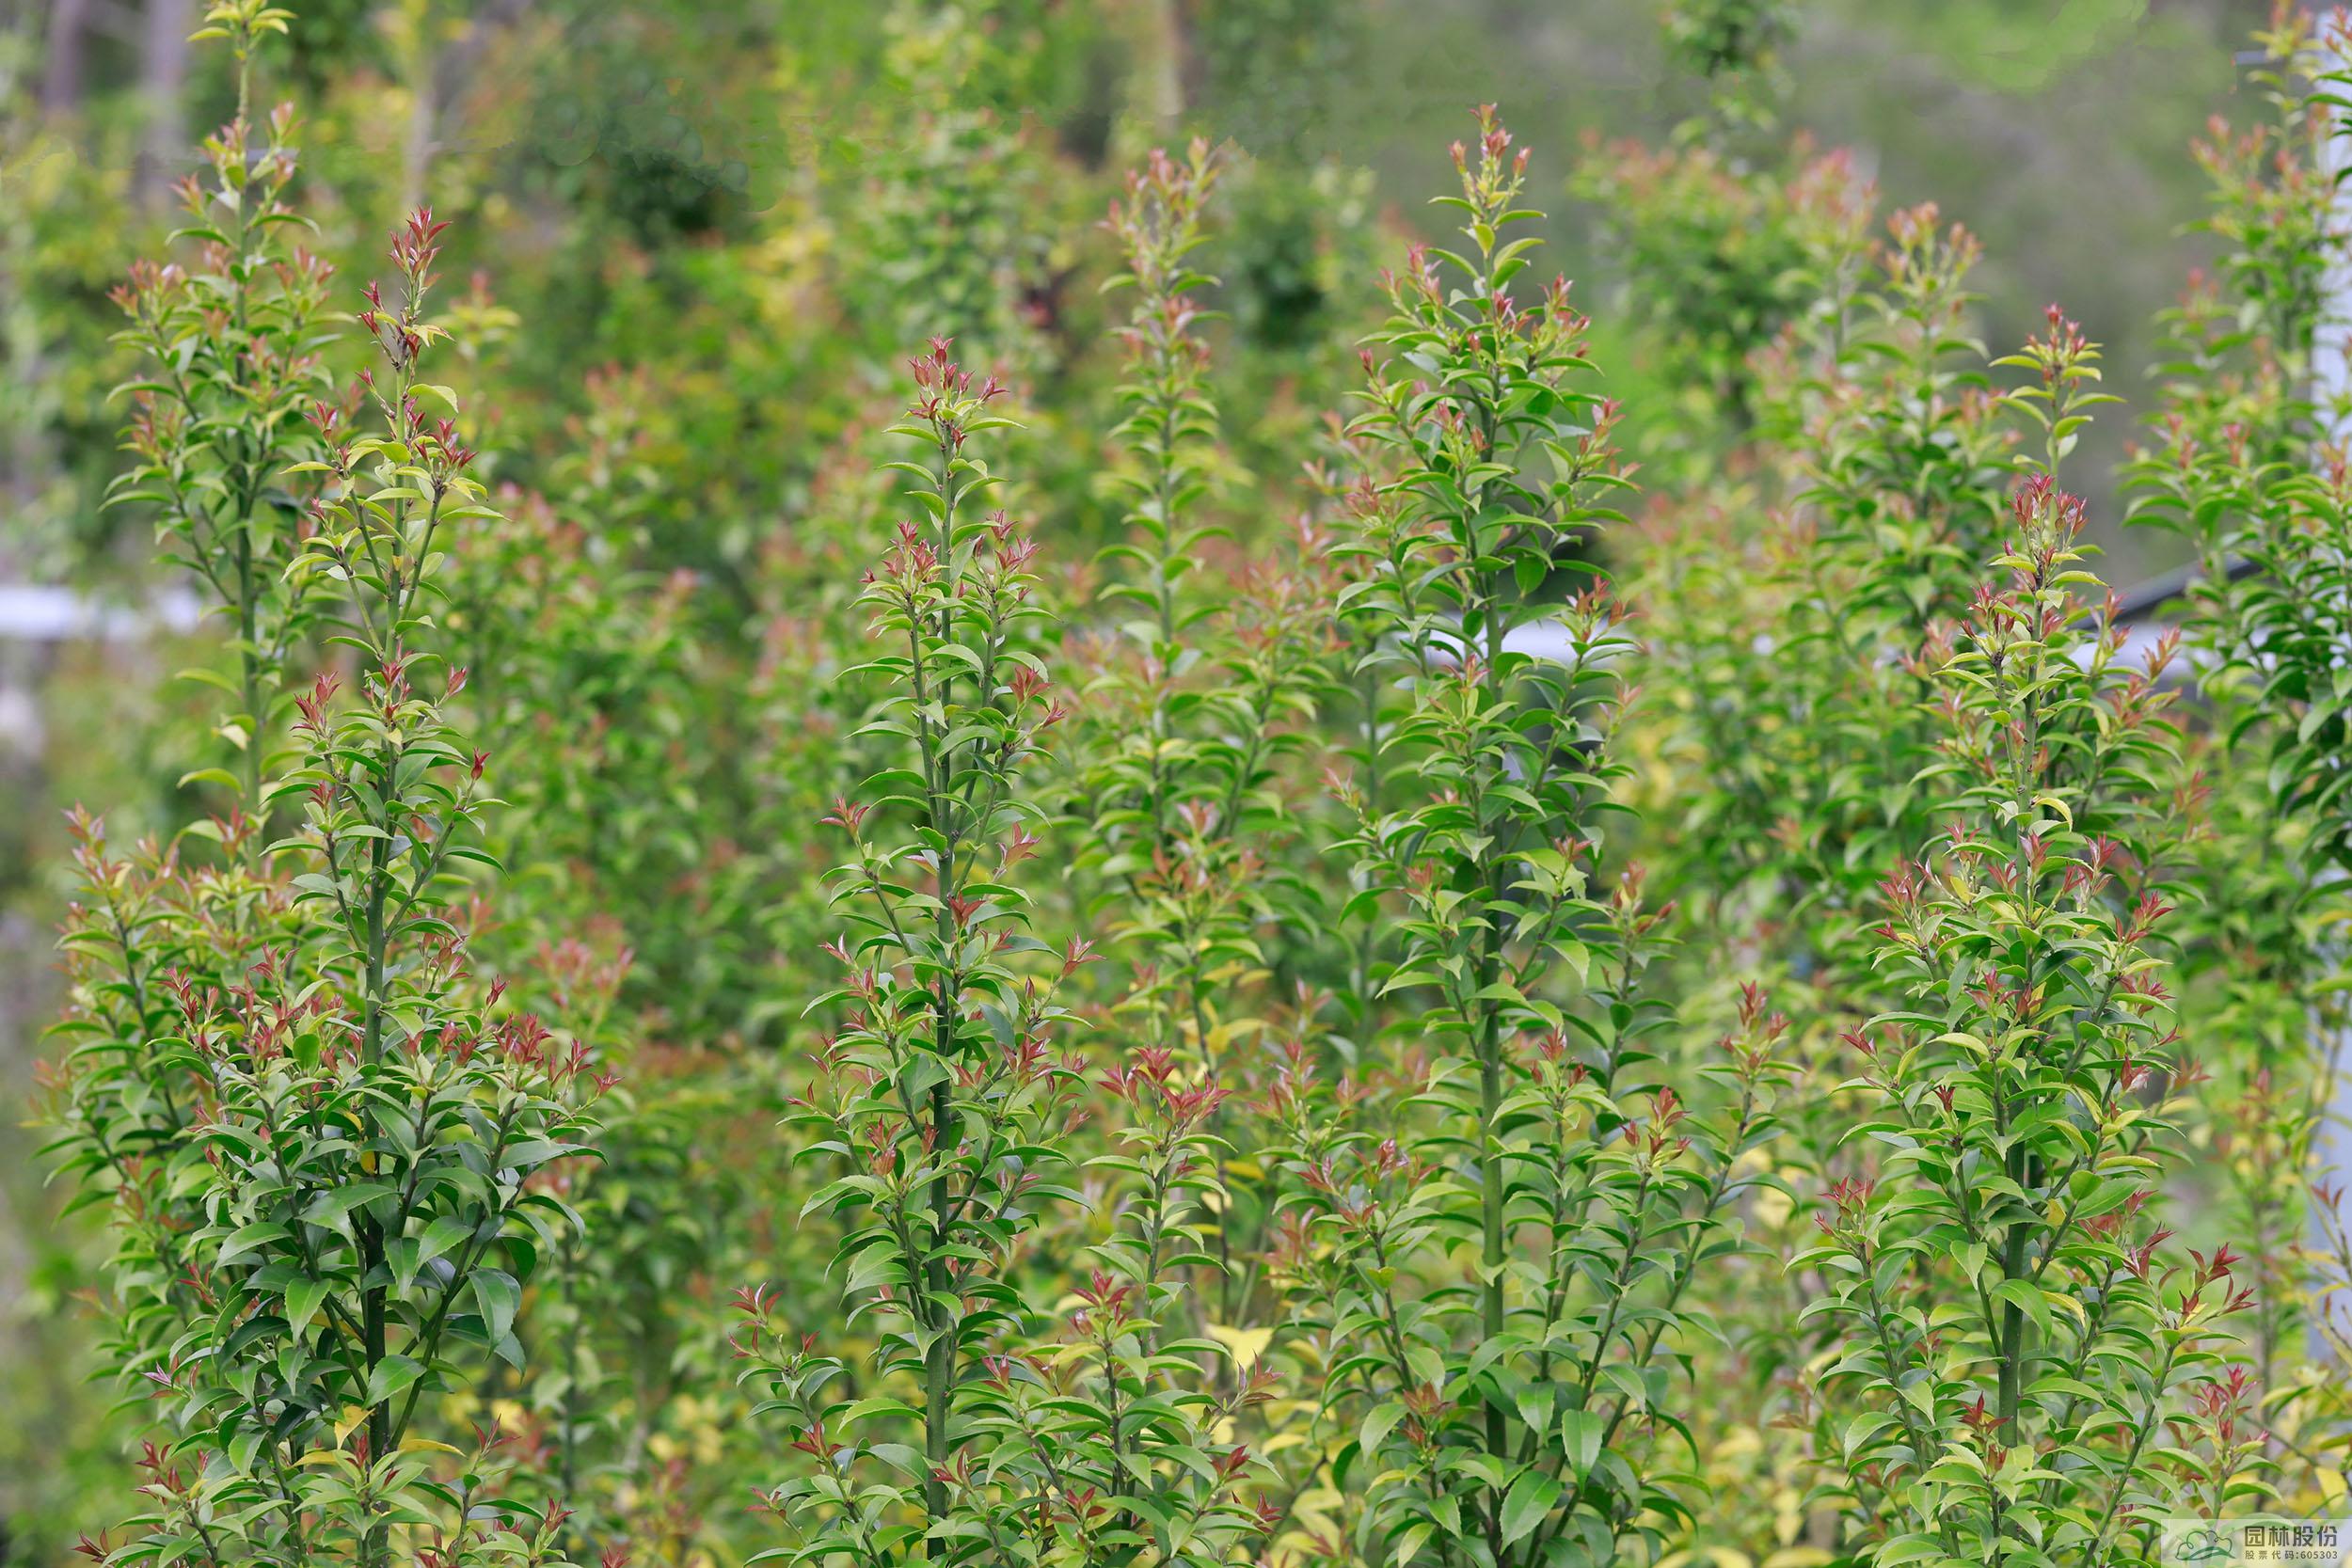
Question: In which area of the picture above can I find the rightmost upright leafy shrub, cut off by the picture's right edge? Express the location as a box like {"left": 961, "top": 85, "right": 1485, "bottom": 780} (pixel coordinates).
{"left": 2126, "top": 5, "right": 2352, "bottom": 1485}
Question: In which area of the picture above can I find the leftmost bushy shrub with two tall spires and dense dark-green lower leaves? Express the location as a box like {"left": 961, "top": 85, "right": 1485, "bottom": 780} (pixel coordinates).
{"left": 56, "top": 24, "right": 612, "bottom": 1568}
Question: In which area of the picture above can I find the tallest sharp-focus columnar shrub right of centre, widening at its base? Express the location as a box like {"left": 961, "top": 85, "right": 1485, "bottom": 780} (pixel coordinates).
{"left": 1275, "top": 108, "right": 1773, "bottom": 1563}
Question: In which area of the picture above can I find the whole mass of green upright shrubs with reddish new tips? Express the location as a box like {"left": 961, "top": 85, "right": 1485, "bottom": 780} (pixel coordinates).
{"left": 13, "top": 0, "right": 2352, "bottom": 1568}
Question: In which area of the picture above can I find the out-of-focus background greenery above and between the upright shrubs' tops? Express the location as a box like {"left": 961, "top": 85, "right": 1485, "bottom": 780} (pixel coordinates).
{"left": 0, "top": 0, "right": 2263, "bottom": 1563}
